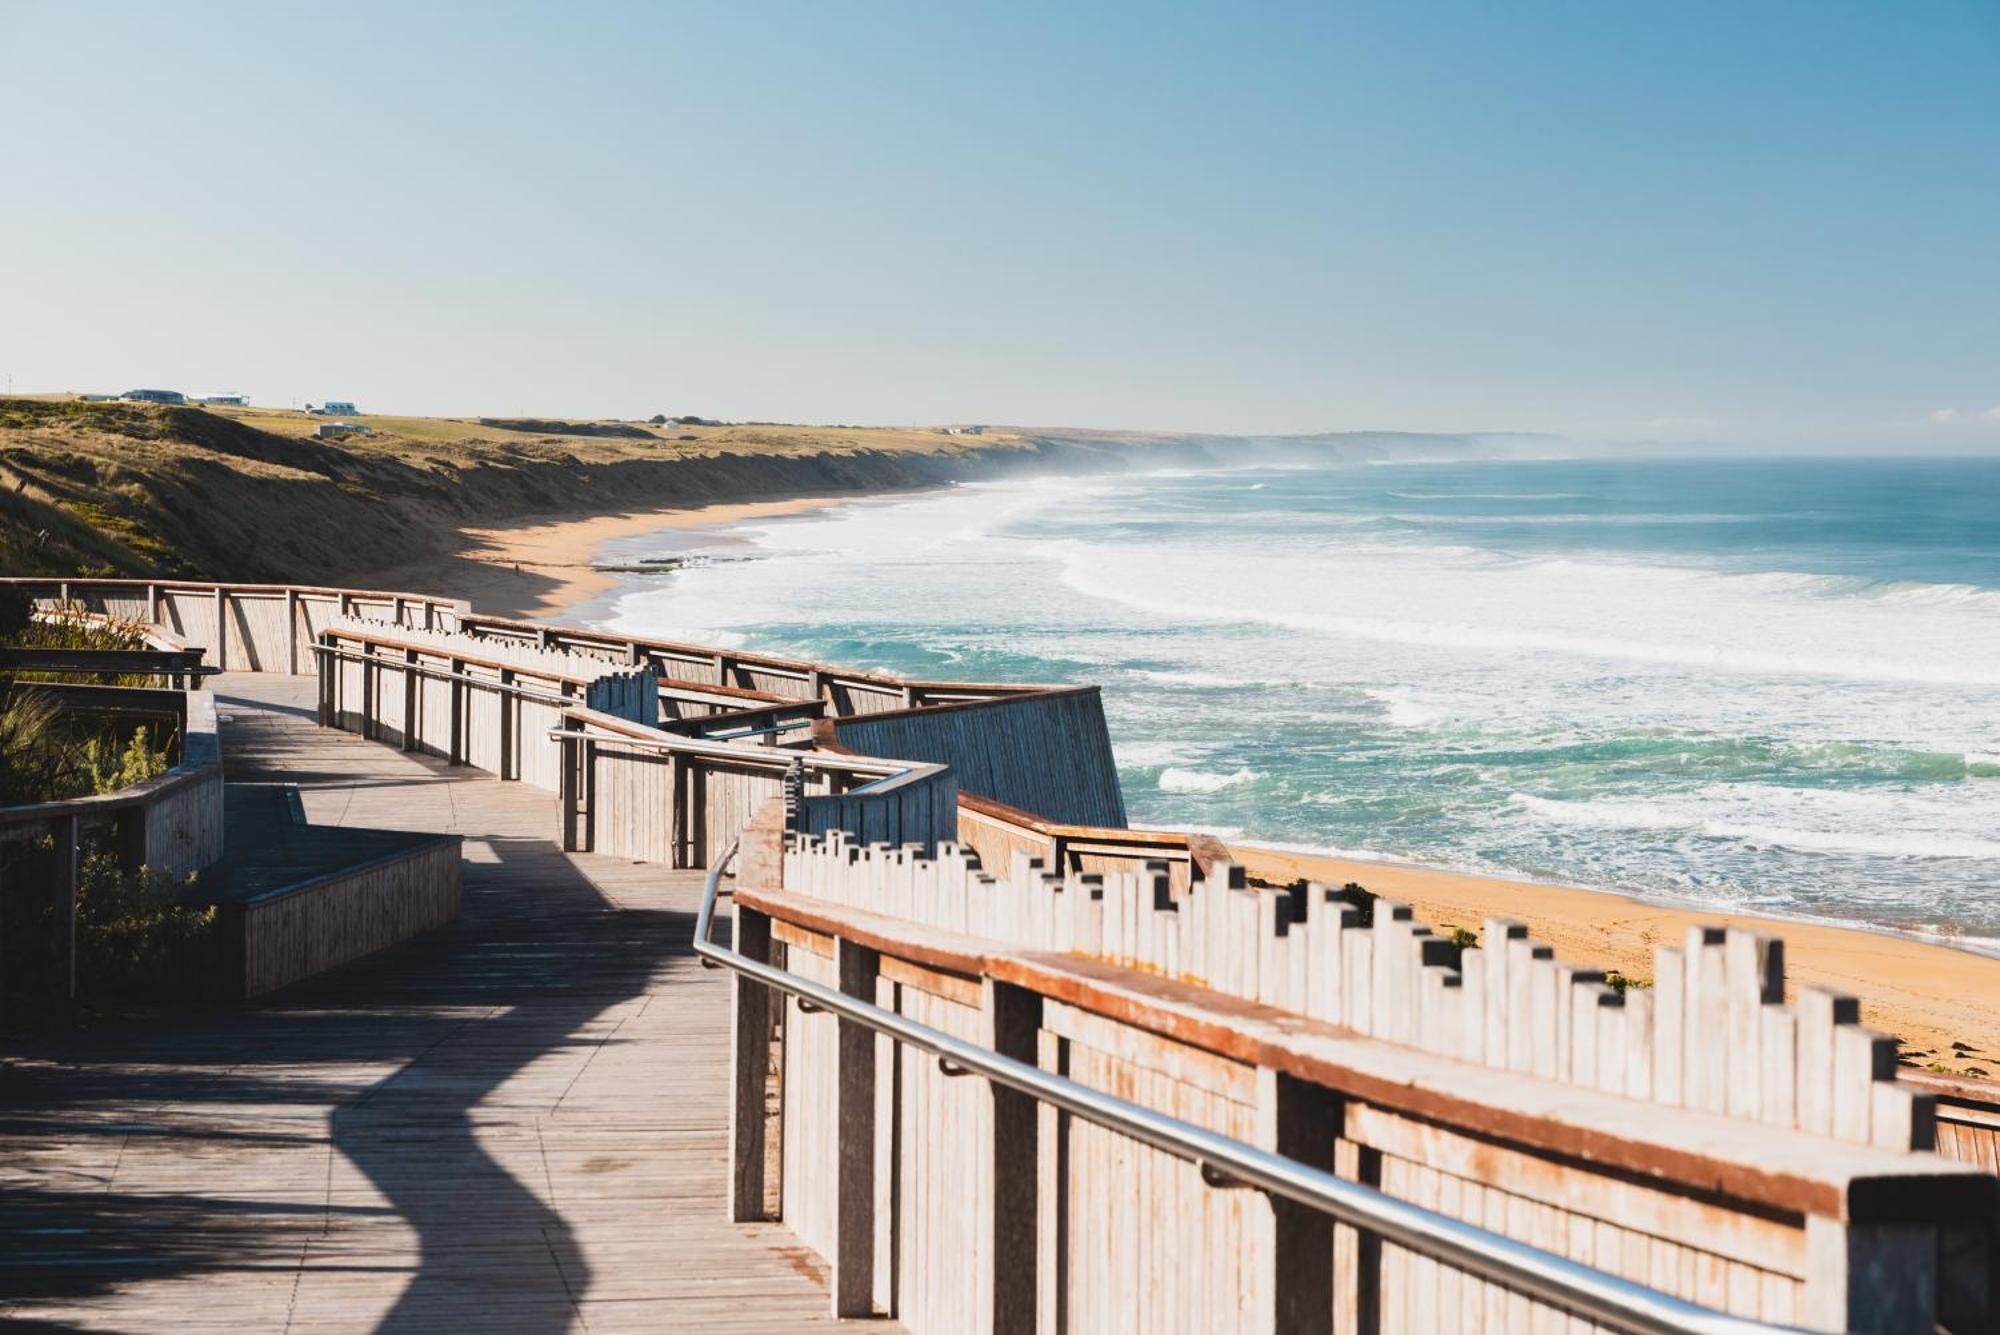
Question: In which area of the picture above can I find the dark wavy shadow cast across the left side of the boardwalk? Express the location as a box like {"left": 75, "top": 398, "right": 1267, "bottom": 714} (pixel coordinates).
{"left": 0, "top": 827, "right": 692, "bottom": 1331}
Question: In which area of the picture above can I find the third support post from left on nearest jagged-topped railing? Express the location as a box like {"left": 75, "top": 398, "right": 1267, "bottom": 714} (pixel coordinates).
{"left": 980, "top": 977, "right": 1042, "bottom": 1335}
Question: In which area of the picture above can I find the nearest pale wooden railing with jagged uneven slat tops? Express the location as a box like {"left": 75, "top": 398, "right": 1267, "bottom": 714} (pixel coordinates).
{"left": 732, "top": 815, "right": 2000, "bottom": 1335}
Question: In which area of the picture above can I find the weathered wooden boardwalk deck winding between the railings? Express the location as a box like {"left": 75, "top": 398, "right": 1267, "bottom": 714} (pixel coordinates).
{"left": 0, "top": 675, "right": 884, "bottom": 1331}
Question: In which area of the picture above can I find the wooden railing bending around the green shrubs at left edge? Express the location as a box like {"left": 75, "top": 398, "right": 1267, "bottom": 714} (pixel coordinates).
{"left": 0, "top": 685, "right": 222, "bottom": 997}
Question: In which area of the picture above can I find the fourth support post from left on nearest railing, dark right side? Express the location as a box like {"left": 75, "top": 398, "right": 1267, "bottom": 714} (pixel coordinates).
{"left": 1254, "top": 1067, "right": 1342, "bottom": 1335}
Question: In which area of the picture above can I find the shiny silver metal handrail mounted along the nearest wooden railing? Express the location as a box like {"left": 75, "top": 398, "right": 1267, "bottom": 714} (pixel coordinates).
{"left": 694, "top": 839, "right": 1788, "bottom": 1335}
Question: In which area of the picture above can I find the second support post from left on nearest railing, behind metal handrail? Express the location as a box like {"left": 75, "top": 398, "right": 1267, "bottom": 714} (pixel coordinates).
{"left": 832, "top": 937, "right": 882, "bottom": 1317}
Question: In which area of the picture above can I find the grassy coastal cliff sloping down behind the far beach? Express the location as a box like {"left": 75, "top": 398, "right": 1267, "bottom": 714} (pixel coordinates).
{"left": 0, "top": 398, "right": 1116, "bottom": 582}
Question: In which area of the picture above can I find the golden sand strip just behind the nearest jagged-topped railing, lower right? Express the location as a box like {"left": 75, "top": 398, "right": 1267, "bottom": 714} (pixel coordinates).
{"left": 1230, "top": 845, "right": 2000, "bottom": 1075}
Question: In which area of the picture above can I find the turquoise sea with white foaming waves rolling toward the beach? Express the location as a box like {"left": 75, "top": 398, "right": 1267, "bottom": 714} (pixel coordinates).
{"left": 610, "top": 460, "right": 2000, "bottom": 939}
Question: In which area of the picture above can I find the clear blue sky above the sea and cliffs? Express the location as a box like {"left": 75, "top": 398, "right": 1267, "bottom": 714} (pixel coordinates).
{"left": 0, "top": 0, "right": 2000, "bottom": 450}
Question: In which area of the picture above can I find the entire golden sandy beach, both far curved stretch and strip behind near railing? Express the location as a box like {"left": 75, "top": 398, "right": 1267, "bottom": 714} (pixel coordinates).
{"left": 376, "top": 496, "right": 2000, "bottom": 1075}
